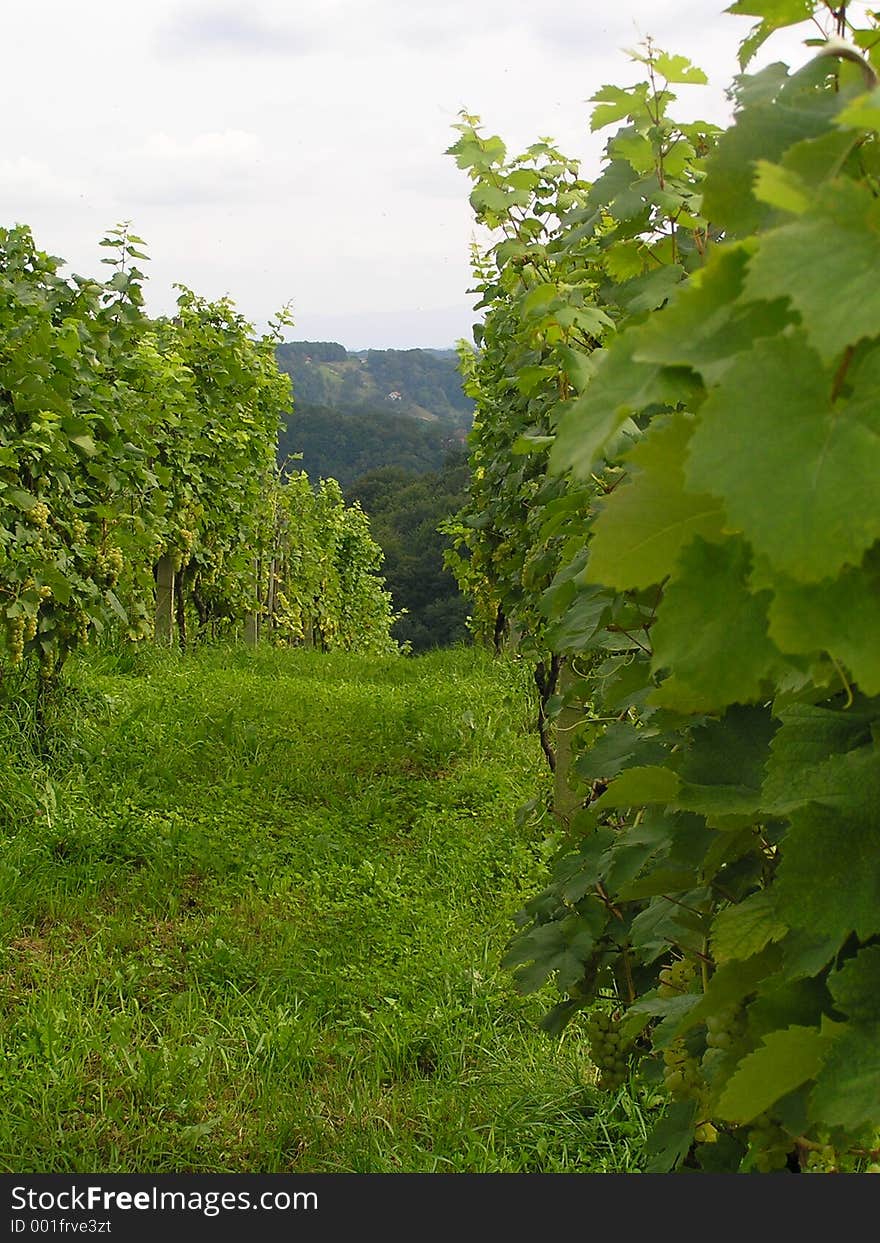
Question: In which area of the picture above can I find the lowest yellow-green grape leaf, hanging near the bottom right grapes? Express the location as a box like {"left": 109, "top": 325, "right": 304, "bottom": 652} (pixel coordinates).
{"left": 717, "top": 1027, "right": 832, "bottom": 1125}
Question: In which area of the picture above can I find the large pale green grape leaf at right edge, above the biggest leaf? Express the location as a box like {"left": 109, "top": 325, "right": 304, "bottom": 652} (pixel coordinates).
{"left": 746, "top": 179, "right": 880, "bottom": 363}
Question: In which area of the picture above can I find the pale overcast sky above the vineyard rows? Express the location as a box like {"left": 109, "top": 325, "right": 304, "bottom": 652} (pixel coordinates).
{"left": 0, "top": 0, "right": 845, "bottom": 349}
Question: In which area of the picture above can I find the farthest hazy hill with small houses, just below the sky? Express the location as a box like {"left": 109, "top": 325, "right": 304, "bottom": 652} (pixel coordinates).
{"left": 276, "top": 341, "right": 474, "bottom": 430}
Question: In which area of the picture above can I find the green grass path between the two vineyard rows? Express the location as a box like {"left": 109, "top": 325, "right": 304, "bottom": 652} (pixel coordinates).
{"left": 0, "top": 650, "right": 646, "bottom": 1172}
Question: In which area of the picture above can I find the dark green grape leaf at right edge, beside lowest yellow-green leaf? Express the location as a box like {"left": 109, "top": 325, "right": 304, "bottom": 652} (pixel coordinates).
{"left": 809, "top": 1023, "right": 880, "bottom": 1134}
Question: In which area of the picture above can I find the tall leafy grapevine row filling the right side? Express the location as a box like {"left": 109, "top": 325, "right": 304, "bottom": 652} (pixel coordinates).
{"left": 451, "top": 2, "right": 880, "bottom": 1172}
